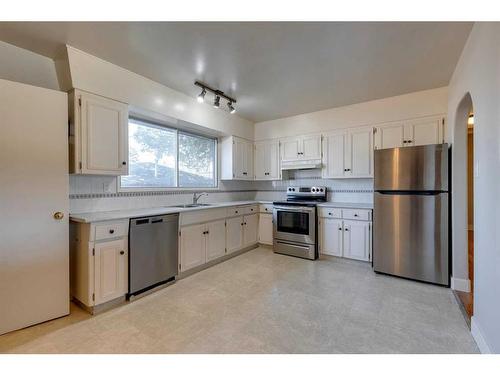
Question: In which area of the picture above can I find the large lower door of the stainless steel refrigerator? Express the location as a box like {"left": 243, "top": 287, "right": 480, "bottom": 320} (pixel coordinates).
{"left": 373, "top": 192, "right": 449, "bottom": 285}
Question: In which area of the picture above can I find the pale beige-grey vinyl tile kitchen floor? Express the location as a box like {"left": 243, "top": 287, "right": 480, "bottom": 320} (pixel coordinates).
{"left": 0, "top": 247, "right": 478, "bottom": 353}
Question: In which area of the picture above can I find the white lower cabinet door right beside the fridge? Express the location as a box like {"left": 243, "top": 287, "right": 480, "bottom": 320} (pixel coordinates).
{"left": 343, "top": 220, "right": 371, "bottom": 261}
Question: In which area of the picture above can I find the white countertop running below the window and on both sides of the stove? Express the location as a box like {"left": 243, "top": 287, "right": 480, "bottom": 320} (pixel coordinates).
{"left": 70, "top": 201, "right": 373, "bottom": 223}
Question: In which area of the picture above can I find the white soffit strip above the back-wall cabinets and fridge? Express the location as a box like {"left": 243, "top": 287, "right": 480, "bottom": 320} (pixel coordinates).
{"left": 255, "top": 87, "right": 448, "bottom": 140}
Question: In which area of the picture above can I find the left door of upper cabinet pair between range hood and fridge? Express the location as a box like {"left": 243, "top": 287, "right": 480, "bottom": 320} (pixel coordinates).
{"left": 322, "top": 131, "right": 347, "bottom": 178}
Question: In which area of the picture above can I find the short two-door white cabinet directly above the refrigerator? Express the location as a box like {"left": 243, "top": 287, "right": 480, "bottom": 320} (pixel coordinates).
{"left": 375, "top": 117, "right": 445, "bottom": 149}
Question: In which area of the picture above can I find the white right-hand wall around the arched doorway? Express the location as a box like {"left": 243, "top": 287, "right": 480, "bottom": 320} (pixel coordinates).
{"left": 448, "top": 23, "right": 500, "bottom": 353}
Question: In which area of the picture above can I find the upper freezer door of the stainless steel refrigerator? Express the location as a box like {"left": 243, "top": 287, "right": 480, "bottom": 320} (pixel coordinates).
{"left": 374, "top": 143, "right": 448, "bottom": 191}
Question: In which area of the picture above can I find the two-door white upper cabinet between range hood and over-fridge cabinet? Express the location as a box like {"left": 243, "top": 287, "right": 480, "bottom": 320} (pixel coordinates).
{"left": 322, "top": 127, "right": 373, "bottom": 178}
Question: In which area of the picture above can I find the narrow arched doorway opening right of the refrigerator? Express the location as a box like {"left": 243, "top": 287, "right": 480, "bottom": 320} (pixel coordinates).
{"left": 452, "top": 93, "right": 474, "bottom": 322}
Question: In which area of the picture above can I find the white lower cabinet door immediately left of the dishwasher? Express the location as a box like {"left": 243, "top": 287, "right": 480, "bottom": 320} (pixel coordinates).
{"left": 94, "top": 238, "right": 128, "bottom": 305}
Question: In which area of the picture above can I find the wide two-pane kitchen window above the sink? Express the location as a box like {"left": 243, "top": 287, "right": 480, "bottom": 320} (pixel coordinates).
{"left": 120, "top": 118, "right": 217, "bottom": 190}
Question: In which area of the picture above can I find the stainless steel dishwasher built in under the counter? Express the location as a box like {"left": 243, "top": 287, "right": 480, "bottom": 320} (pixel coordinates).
{"left": 128, "top": 214, "right": 179, "bottom": 297}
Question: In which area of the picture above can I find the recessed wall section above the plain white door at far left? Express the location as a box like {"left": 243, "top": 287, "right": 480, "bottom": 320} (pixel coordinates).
{"left": 0, "top": 41, "right": 59, "bottom": 90}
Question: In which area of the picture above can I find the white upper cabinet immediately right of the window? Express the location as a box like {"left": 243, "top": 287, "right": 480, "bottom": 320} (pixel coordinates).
{"left": 221, "top": 136, "right": 253, "bottom": 180}
